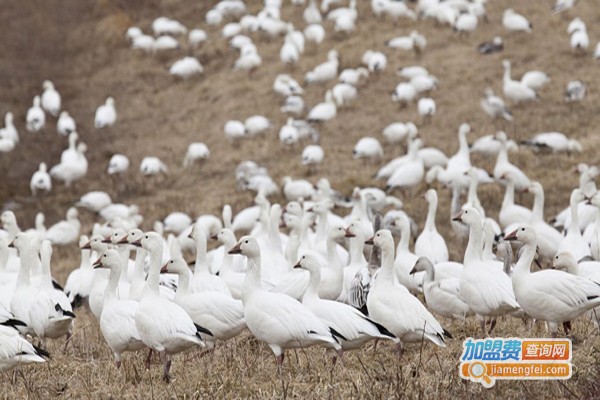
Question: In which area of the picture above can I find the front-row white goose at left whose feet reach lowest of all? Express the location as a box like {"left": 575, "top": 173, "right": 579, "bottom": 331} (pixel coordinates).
{"left": 131, "top": 232, "right": 212, "bottom": 382}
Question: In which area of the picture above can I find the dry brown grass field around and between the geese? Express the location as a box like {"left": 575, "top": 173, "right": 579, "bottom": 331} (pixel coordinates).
{"left": 0, "top": 0, "right": 600, "bottom": 399}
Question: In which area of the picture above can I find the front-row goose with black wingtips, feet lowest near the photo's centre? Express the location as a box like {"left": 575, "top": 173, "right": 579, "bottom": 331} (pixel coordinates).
{"left": 229, "top": 236, "right": 341, "bottom": 373}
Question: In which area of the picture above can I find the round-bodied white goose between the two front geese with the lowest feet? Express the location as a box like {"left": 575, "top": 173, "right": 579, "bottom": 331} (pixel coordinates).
{"left": 161, "top": 256, "right": 246, "bottom": 349}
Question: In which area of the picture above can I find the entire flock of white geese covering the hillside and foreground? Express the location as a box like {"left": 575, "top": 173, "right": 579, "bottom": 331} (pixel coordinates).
{"left": 0, "top": 0, "right": 600, "bottom": 390}
